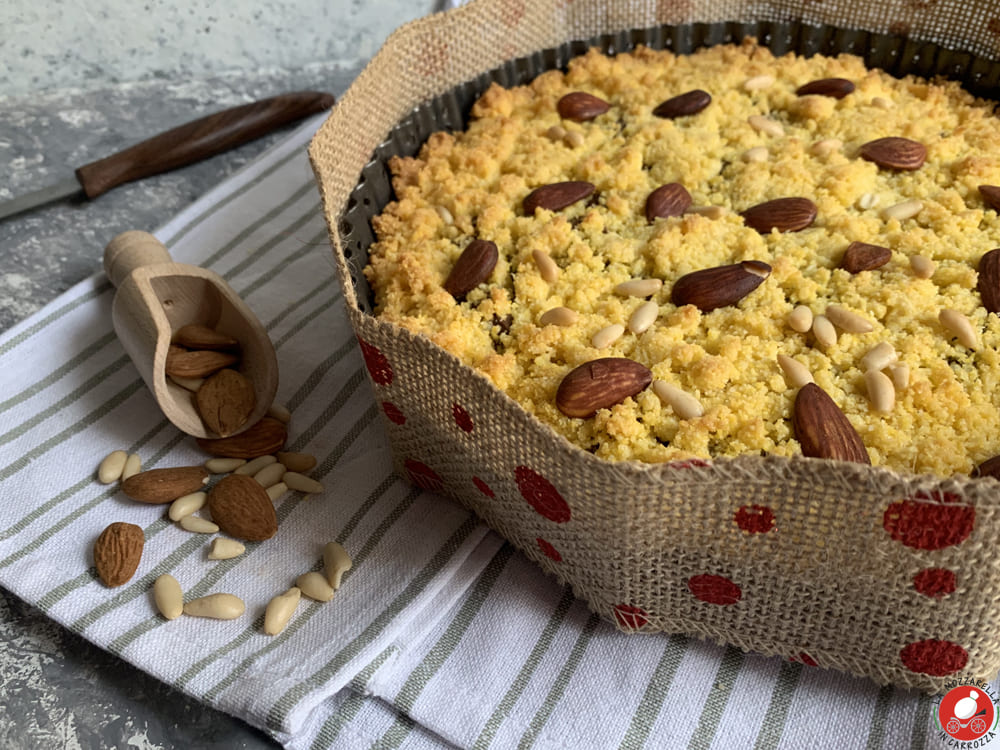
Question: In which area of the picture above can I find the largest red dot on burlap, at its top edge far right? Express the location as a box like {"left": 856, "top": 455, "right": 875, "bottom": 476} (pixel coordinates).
{"left": 882, "top": 491, "right": 976, "bottom": 550}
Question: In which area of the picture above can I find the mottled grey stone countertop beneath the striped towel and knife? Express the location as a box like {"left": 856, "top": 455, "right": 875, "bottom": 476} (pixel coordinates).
{"left": 0, "top": 61, "right": 358, "bottom": 750}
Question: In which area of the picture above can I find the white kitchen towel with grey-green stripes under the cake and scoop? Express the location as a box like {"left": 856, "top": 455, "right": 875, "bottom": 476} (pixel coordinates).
{"left": 0, "top": 107, "right": 988, "bottom": 749}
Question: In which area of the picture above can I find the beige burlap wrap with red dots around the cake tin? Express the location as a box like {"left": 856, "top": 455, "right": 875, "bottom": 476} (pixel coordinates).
{"left": 310, "top": 0, "right": 1000, "bottom": 692}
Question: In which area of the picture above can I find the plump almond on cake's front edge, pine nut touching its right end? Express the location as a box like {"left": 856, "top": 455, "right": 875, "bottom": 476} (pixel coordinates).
{"left": 556, "top": 357, "right": 653, "bottom": 419}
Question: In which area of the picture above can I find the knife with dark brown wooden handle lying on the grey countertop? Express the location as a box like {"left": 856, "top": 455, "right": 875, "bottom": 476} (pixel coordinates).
{"left": 0, "top": 91, "right": 334, "bottom": 220}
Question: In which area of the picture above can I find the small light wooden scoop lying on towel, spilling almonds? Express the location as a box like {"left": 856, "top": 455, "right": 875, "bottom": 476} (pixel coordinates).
{"left": 104, "top": 231, "right": 278, "bottom": 438}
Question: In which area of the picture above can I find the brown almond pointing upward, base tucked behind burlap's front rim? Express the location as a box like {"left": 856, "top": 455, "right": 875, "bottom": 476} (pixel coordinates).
{"left": 792, "top": 383, "right": 871, "bottom": 464}
